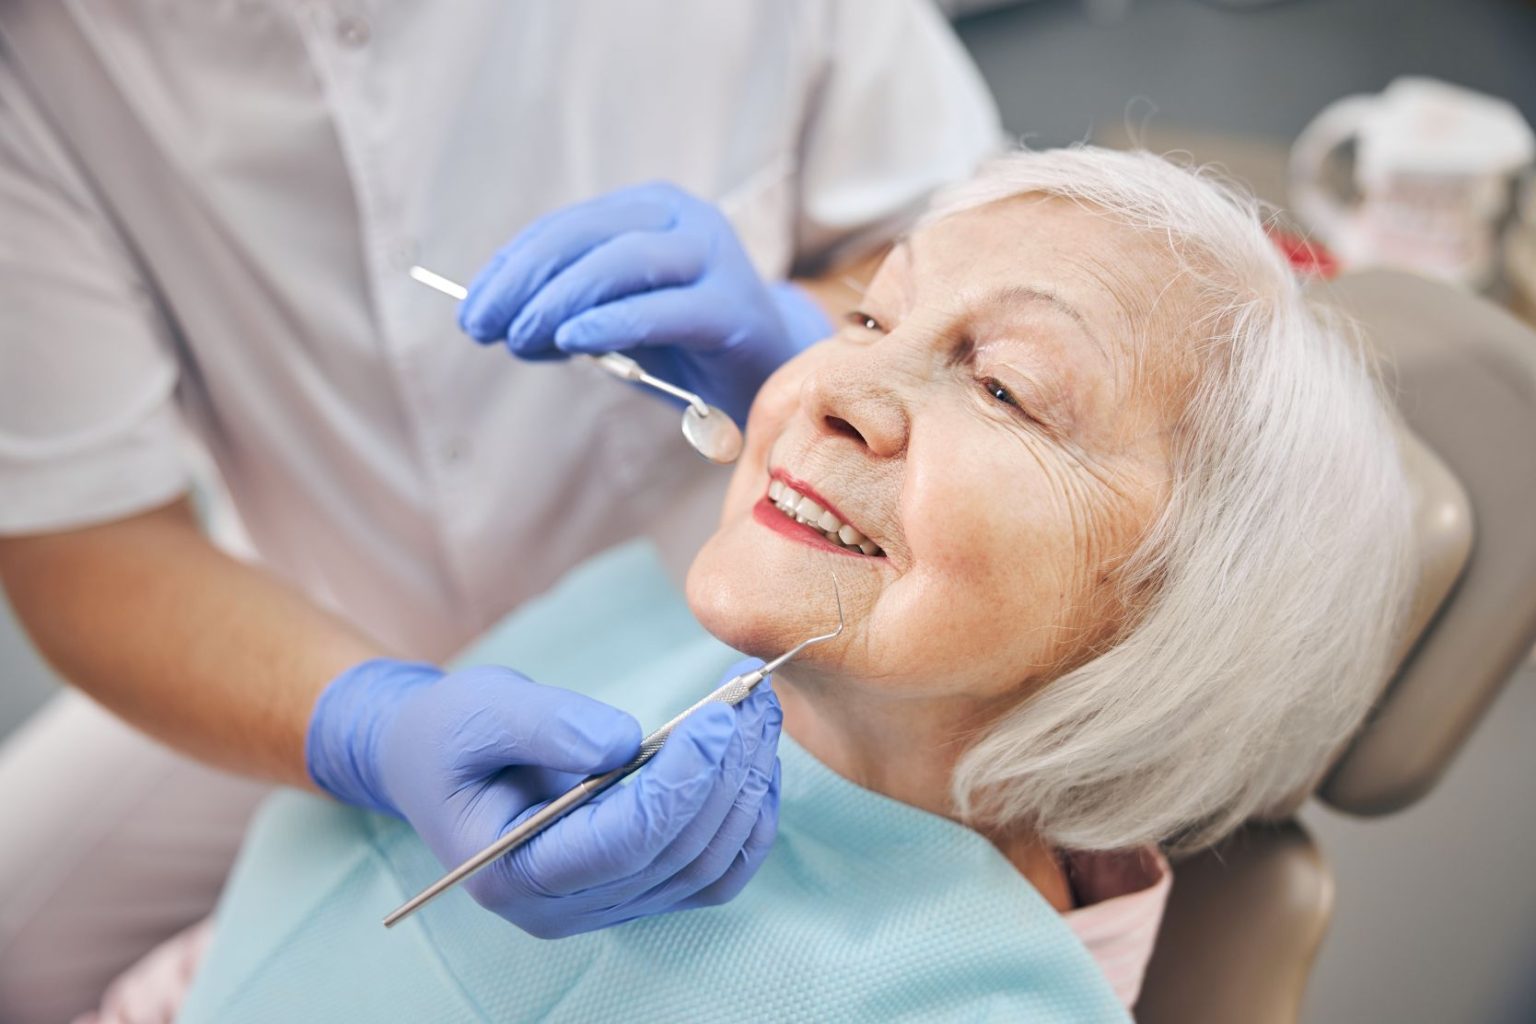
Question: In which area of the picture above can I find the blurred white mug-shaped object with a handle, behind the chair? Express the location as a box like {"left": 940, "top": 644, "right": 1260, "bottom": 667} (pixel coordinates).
{"left": 1290, "top": 78, "right": 1536, "bottom": 287}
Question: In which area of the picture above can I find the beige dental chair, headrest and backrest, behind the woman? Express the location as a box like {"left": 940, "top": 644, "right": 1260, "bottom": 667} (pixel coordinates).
{"left": 1137, "top": 270, "right": 1536, "bottom": 1024}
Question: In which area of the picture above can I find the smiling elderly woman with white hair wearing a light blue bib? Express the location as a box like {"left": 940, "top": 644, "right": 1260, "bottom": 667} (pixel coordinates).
{"left": 171, "top": 149, "right": 1412, "bottom": 1021}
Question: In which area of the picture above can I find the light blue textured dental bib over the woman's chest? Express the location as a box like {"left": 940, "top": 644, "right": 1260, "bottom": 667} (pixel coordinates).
{"left": 178, "top": 545, "right": 1129, "bottom": 1024}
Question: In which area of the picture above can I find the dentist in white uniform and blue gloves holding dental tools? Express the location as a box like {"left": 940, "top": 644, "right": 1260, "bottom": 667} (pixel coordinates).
{"left": 0, "top": 0, "right": 1000, "bottom": 1022}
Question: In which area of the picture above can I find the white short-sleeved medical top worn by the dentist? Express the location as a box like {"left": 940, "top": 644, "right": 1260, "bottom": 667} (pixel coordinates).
{"left": 0, "top": 0, "right": 1001, "bottom": 657}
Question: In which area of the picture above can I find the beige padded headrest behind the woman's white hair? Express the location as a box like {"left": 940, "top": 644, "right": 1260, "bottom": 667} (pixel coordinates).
{"left": 1318, "top": 270, "right": 1536, "bottom": 814}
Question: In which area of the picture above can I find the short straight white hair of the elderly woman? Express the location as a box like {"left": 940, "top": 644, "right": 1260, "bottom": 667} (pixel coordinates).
{"left": 925, "top": 146, "right": 1416, "bottom": 851}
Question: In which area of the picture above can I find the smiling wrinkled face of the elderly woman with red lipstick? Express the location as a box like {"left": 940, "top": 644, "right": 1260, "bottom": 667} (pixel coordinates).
{"left": 688, "top": 197, "right": 1192, "bottom": 703}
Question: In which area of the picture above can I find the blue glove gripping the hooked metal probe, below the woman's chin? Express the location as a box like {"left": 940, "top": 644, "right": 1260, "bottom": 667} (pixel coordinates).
{"left": 306, "top": 659, "right": 783, "bottom": 938}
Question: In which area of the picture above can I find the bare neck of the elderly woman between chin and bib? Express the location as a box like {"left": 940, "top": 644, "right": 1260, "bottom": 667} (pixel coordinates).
{"left": 774, "top": 674, "right": 1072, "bottom": 912}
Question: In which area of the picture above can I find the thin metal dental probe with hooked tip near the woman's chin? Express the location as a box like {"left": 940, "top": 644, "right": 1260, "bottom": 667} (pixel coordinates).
{"left": 384, "top": 574, "right": 843, "bottom": 927}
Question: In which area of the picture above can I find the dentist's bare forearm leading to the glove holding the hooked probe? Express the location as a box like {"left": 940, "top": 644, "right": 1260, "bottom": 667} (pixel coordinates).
{"left": 0, "top": 500, "right": 384, "bottom": 786}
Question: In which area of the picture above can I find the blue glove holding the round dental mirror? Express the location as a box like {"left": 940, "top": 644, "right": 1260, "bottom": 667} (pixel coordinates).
{"left": 459, "top": 183, "right": 833, "bottom": 424}
